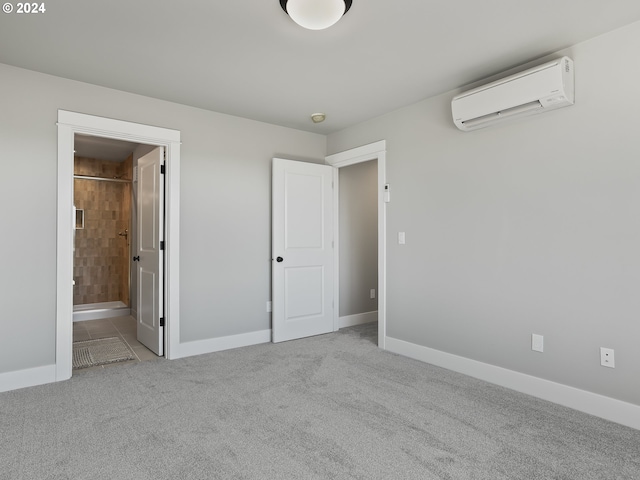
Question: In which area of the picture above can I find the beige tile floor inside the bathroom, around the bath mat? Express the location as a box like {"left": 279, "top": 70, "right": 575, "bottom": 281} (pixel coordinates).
{"left": 73, "top": 316, "right": 162, "bottom": 374}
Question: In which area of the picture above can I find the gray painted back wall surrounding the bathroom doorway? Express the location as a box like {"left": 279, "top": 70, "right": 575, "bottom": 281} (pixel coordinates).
{"left": 0, "top": 65, "right": 326, "bottom": 373}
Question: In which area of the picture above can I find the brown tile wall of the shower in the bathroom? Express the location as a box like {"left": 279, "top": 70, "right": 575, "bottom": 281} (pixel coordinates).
{"left": 73, "top": 156, "right": 133, "bottom": 305}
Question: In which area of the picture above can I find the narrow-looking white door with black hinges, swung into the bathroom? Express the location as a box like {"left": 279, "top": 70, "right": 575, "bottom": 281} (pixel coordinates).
{"left": 134, "top": 147, "right": 164, "bottom": 355}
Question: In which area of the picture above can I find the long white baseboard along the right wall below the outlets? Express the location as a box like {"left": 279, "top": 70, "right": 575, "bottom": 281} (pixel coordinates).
{"left": 385, "top": 337, "right": 640, "bottom": 430}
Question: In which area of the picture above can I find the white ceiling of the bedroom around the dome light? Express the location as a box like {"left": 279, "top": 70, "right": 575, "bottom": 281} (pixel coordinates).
{"left": 0, "top": 0, "right": 640, "bottom": 133}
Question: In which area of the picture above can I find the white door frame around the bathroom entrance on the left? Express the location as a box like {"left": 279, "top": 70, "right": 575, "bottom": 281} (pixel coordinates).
{"left": 55, "top": 110, "right": 180, "bottom": 381}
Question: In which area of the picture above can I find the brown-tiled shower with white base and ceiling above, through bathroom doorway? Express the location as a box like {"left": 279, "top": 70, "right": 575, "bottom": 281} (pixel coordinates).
{"left": 73, "top": 134, "right": 138, "bottom": 322}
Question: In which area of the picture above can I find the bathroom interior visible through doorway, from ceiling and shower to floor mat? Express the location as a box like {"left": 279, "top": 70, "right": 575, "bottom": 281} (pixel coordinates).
{"left": 73, "top": 134, "right": 163, "bottom": 372}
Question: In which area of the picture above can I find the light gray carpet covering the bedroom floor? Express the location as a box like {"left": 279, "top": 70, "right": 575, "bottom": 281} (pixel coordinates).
{"left": 0, "top": 325, "right": 640, "bottom": 480}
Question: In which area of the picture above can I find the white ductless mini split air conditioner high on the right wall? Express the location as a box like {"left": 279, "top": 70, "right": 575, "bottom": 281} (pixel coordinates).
{"left": 451, "top": 57, "right": 574, "bottom": 131}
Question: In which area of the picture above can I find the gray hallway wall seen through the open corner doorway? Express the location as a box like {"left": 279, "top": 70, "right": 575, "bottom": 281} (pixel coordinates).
{"left": 338, "top": 160, "right": 378, "bottom": 317}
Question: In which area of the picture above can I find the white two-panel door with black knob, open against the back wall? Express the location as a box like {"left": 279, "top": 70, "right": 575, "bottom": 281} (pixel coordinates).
{"left": 272, "top": 158, "right": 335, "bottom": 342}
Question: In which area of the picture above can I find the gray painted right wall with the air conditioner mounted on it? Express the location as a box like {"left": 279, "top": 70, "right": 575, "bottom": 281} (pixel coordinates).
{"left": 328, "top": 23, "right": 640, "bottom": 405}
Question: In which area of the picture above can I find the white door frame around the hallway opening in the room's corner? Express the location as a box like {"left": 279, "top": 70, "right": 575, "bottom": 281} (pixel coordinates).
{"left": 325, "top": 140, "right": 387, "bottom": 350}
